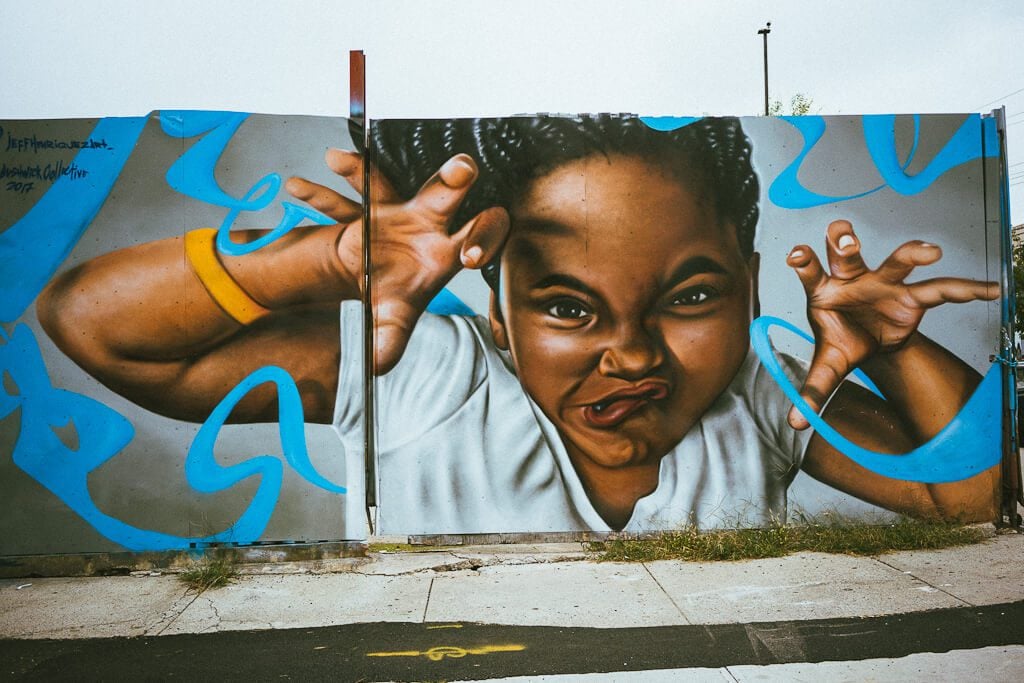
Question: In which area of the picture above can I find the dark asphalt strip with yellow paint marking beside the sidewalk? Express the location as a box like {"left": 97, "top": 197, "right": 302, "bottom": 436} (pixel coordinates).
{"left": 0, "top": 601, "right": 1024, "bottom": 681}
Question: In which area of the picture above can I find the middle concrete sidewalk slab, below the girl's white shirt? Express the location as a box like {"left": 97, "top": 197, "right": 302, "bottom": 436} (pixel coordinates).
{"left": 426, "top": 562, "right": 688, "bottom": 627}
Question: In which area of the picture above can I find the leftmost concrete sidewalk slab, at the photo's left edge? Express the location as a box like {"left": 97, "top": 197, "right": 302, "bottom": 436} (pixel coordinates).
{"left": 0, "top": 574, "right": 191, "bottom": 638}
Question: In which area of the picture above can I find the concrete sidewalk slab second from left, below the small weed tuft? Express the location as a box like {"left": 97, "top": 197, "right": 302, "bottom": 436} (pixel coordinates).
{"left": 160, "top": 573, "right": 430, "bottom": 635}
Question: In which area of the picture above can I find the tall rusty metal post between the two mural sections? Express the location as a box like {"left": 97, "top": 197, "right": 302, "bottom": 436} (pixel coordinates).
{"left": 348, "top": 50, "right": 377, "bottom": 533}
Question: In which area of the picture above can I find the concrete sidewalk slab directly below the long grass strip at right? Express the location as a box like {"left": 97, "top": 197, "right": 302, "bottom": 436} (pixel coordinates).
{"left": 648, "top": 553, "right": 965, "bottom": 624}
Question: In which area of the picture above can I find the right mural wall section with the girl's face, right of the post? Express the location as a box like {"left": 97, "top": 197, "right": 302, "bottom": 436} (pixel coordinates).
{"left": 364, "top": 116, "right": 1000, "bottom": 535}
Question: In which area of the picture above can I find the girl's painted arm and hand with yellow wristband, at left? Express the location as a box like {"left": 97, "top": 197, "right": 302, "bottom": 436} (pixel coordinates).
{"left": 37, "top": 150, "right": 508, "bottom": 423}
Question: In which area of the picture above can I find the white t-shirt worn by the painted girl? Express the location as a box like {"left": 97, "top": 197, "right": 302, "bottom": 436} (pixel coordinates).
{"left": 335, "top": 302, "right": 811, "bottom": 535}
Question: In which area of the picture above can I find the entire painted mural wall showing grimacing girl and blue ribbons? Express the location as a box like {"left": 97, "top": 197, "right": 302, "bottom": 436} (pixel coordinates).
{"left": 0, "top": 112, "right": 1002, "bottom": 555}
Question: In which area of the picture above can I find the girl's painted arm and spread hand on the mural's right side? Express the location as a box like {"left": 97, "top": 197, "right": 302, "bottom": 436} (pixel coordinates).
{"left": 788, "top": 220, "right": 998, "bottom": 520}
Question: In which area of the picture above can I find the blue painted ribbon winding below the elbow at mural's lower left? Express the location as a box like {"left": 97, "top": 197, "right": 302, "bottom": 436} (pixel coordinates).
{"left": 0, "top": 325, "right": 345, "bottom": 551}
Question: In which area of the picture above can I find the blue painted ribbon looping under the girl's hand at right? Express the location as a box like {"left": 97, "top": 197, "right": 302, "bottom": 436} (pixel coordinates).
{"left": 751, "top": 315, "right": 1002, "bottom": 483}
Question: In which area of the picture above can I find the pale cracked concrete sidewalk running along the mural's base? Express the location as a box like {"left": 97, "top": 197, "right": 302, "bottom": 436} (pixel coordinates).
{"left": 0, "top": 533, "right": 1024, "bottom": 680}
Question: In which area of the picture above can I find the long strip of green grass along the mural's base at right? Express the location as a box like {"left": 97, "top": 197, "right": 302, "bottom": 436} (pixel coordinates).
{"left": 589, "top": 520, "right": 987, "bottom": 562}
